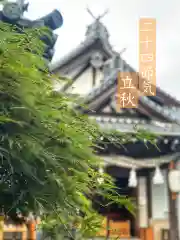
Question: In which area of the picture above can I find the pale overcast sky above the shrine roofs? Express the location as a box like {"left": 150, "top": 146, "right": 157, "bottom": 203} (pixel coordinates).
{"left": 24, "top": 0, "right": 180, "bottom": 99}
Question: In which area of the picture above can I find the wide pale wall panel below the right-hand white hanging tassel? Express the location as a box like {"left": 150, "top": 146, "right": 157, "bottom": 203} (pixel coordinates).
{"left": 151, "top": 170, "right": 169, "bottom": 220}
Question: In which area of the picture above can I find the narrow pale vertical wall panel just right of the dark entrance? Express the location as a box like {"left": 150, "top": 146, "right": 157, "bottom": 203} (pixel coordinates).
{"left": 138, "top": 177, "right": 148, "bottom": 227}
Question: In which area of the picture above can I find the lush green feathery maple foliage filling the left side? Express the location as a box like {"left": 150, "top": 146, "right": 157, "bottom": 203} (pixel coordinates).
{"left": 0, "top": 23, "right": 157, "bottom": 239}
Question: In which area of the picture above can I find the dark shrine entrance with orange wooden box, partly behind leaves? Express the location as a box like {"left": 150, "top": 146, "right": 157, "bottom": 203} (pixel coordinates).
{"left": 93, "top": 166, "right": 139, "bottom": 237}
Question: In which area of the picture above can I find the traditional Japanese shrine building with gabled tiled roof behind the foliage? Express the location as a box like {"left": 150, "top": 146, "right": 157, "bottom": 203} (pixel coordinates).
{"left": 51, "top": 13, "right": 180, "bottom": 240}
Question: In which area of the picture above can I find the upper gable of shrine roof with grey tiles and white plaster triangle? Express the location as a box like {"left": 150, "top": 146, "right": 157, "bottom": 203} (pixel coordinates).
{"left": 51, "top": 11, "right": 180, "bottom": 122}
